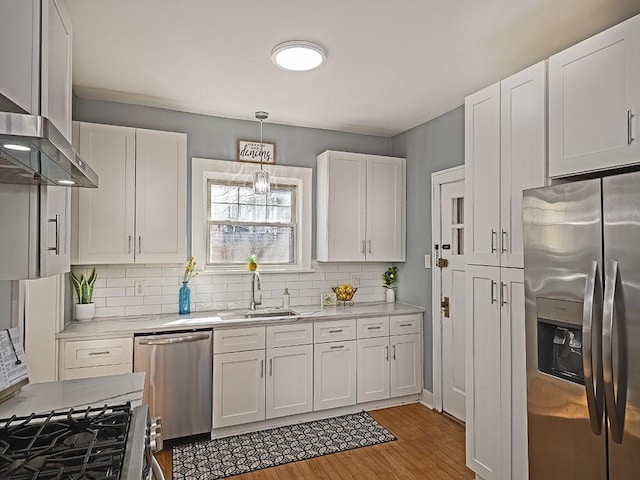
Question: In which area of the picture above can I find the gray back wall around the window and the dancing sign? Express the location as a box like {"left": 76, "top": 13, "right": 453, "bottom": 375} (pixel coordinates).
{"left": 73, "top": 97, "right": 391, "bottom": 258}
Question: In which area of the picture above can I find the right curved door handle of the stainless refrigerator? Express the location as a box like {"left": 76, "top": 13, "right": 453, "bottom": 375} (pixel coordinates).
{"left": 602, "top": 260, "right": 627, "bottom": 444}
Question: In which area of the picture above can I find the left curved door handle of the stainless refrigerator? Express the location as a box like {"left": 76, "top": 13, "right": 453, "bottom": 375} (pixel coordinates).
{"left": 582, "top": 261, "right": 604, "bottom": 435}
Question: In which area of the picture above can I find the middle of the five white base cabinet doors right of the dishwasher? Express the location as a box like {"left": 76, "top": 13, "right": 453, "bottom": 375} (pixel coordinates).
{"left": 313, "top": 340, "right": 356, "bottom": 410}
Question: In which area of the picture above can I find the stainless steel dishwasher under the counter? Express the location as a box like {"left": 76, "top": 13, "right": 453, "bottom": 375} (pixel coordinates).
{"left": 133, "top": 330, "right": 213, "bottom": 439}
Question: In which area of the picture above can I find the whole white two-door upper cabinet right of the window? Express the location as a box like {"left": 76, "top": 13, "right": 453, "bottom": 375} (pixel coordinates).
{"left": 316, "top": 151, "right": 406, "bottom": 262}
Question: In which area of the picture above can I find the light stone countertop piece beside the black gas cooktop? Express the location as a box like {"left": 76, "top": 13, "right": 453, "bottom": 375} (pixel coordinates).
{"left": 0, "top": 373, "right": 144, "bottom": 418}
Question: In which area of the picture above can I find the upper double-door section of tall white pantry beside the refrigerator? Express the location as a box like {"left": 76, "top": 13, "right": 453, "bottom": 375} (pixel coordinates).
{"left": 465, "top": 62, "right": 547, "bottom": 268}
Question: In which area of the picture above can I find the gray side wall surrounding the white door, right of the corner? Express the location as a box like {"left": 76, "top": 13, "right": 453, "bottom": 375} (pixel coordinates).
{"left": 392, "top": 106, "right": 464, "bottom": 391}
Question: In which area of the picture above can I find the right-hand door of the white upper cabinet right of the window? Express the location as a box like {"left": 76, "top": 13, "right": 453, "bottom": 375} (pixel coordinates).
{"left": 366, "top": 155, "right": 406, "bottom": 262}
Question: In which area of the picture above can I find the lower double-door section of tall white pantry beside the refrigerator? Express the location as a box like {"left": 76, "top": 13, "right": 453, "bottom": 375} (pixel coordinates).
{"left": 465, "top": 265, "right": 528, "bottom": 480}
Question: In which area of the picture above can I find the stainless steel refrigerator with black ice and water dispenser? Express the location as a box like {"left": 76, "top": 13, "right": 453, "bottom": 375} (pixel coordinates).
{"left": 524, "top": 172, "right": 640, "bottom": 480}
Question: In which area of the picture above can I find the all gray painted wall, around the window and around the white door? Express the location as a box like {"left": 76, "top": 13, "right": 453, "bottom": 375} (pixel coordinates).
{"left": 74, "top": 98, "right": 464, "bottom": 391}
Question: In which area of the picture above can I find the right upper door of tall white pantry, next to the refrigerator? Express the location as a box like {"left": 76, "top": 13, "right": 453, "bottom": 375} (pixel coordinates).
{"left": 499, "top": 61, "right": 547, "bottom": 268}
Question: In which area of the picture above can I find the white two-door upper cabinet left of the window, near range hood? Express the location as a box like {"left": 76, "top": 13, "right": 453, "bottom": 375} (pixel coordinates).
{"left": 72, "top": 123, "right": 187, "bottom": 264}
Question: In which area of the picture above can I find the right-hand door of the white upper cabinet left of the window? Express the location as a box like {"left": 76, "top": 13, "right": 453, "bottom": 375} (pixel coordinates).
{"left": 134, "top": 129, "right": 187, "bottom": 263}
